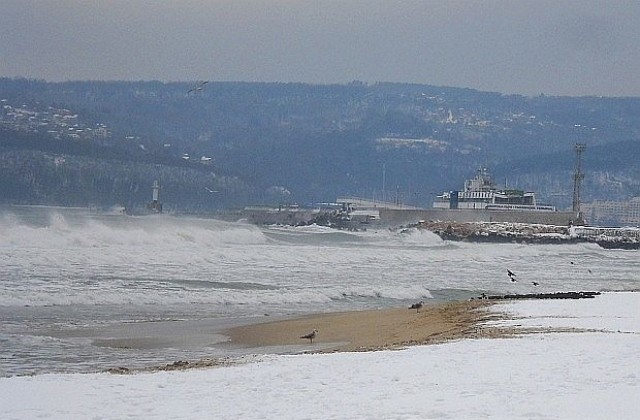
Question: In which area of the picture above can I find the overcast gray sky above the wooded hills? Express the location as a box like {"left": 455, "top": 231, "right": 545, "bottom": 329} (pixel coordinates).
{"left": 0, "top": 0, "right": 640, "bottom": 96}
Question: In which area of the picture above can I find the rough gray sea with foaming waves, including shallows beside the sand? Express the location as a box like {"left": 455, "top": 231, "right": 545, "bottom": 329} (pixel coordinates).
{"left": 0, "top": 206, "right": 640, "bottom": 376}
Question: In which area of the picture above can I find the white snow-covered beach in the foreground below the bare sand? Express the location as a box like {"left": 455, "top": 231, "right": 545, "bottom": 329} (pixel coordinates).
{"left": 0, "top": 292, "right": 640, "bottom": 419}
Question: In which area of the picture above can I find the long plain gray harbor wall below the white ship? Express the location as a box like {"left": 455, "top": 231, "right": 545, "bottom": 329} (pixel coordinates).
{"left": 379, "top": 208, "right": 576, "bottom": 226}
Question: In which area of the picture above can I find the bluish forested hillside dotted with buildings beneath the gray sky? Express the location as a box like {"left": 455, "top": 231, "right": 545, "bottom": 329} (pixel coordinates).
{"left": 0, "top": 79, "right": 640, "bottom": 211}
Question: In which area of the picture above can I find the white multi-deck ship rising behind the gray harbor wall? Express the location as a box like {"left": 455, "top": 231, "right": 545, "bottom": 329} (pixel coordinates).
{"left": 433, "top": 168, "right": 556, "bottom": 212}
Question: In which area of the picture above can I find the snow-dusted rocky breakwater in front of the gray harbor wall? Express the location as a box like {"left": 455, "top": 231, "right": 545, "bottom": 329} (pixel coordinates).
{"left": 416, "top": 221, "right": 640, "bottom": 249}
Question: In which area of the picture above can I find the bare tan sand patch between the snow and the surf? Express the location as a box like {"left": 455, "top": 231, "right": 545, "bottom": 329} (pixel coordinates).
{"left": 225, "top": 300, "right": 496, "bottom": 352}
